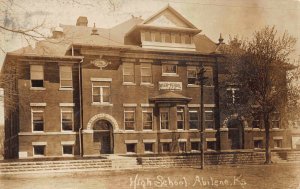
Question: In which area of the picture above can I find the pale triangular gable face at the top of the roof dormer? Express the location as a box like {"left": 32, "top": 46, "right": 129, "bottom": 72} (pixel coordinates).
{"left": 142, "top": 6, "right": 196, "bottom": 29}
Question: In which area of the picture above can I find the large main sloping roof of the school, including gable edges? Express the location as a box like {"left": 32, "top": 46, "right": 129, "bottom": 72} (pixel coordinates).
{"left": 7, "top": 6, "right": 217, "bottom": 56}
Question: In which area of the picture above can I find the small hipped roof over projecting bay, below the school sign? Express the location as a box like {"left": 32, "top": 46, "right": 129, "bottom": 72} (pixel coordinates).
{"left": 150, "top": 91, "right": 192, "bottom": 102}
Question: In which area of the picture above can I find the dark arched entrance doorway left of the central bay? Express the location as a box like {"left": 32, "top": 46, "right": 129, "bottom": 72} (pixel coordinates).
{"left": 93, "top": 120, "right": 113, "bottom": 154}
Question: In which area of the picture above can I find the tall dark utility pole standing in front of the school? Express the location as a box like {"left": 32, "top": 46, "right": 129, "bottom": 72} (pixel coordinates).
{"left": 198, "top": 65, "right": 207, "bottom": 169}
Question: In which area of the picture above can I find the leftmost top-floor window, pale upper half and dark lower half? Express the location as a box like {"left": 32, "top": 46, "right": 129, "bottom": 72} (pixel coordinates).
{"left": 30, "top": 65, "right": 44, "bottom": 87}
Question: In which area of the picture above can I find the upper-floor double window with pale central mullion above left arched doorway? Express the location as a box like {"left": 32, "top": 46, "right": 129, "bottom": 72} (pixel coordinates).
{"left": 92, "top": 81, "right": 111, "bottom": 103}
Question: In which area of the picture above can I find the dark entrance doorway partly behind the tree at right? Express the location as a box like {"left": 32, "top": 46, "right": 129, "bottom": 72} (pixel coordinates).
{"left": 227, "top": 119, "right": 244, "bottom": 149}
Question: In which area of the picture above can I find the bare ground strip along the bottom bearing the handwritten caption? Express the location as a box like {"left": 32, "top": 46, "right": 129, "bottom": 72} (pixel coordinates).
{"left": 0, "top": 164, "right": 300, "bottom": 189}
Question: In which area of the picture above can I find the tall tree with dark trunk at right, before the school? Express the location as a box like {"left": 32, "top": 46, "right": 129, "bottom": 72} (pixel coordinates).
{"left": 224, "top": 26, "right": 300, "bottom": 163}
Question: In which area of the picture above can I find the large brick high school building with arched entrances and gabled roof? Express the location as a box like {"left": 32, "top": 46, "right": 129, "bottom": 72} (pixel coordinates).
{"left": 2, "top": 6, "right": 291, "bottom": 158}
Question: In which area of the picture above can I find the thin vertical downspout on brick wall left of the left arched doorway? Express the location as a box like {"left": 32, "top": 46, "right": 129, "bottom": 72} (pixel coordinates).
{"left": 78, "top": 56, "right": 83, "bottom": 157}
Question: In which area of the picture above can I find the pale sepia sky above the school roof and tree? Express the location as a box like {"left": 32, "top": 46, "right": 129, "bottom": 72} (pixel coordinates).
{"left": 0, "top": 0, "right": 300, "bottom": 122}
